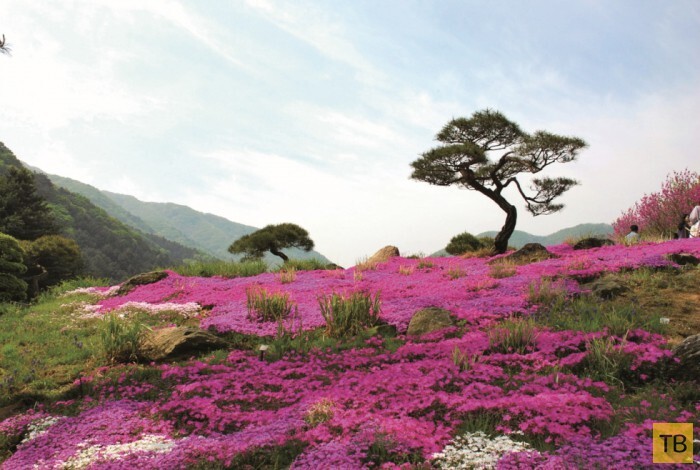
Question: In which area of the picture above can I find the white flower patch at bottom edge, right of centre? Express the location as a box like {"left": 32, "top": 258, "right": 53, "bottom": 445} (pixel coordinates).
{"left": 433, "top": 432, "right": 532, "bottom": 469}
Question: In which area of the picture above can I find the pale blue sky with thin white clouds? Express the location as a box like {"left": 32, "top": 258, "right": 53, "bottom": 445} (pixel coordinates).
{"left": 0, "top": 0, "right": 700, "bottom": 266}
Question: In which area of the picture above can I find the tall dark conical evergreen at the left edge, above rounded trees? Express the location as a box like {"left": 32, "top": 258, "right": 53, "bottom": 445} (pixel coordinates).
{"left": 0, "top": 167, "right": 58, "bottom": 240}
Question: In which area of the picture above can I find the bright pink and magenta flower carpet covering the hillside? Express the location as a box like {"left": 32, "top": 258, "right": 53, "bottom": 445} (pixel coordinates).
{"left": 0, "top": 239, "right": 700, "bottom": 470}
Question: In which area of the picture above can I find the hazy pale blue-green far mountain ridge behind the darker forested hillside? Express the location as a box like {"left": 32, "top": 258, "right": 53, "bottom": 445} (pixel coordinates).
{"left": 48, "top": 175, "right": 330, "bottom": 263}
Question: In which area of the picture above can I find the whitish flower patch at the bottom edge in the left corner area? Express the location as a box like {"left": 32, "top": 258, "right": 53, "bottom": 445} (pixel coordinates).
{"left": 58, "top": 434, "right": 175, "bottom": 470}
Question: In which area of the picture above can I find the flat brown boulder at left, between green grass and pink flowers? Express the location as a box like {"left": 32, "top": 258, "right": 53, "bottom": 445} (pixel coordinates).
{"left": 140, "top": 326, "right": 229, "bottom": 361}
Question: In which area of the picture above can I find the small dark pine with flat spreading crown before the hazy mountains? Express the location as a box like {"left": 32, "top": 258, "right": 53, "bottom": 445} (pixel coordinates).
{"left": 228, "top": 223, "right": 314, "bottom": 263}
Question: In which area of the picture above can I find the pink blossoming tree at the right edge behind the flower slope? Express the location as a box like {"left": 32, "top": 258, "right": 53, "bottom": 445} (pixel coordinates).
{"left": 612, "top": 169, "right": 700, "bottom": 237}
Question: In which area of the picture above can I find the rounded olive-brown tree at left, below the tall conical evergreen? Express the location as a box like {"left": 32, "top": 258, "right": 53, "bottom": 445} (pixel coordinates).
{"left": 21, "top": 235, "right": 83, "bottom": 296}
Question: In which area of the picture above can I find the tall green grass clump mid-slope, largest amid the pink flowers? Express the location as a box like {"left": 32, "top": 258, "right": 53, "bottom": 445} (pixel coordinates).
{"left": 318, "top": 292, "right": 381, "bottom": 338}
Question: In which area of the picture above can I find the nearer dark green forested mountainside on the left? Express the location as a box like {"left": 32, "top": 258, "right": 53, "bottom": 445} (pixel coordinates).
{"left": 0, "top": 142, "right": 207, "bottom": 281}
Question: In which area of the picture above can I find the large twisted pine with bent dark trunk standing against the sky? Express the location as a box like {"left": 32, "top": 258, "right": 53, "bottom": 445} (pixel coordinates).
{"left": 411, "top": 109, "right": 586, "bottom": 253}
